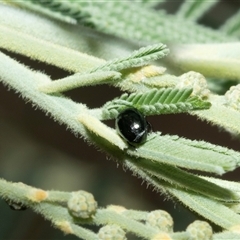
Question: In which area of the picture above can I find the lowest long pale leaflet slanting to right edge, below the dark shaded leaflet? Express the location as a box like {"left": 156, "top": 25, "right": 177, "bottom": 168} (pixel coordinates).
{"left": 126, "top": 162, "right": 240, "bottom": 229}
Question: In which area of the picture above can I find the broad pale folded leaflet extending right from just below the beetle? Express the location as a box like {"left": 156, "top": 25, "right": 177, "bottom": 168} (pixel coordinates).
{"left": 128, "top": 133, "right": 240, "bottom": 174}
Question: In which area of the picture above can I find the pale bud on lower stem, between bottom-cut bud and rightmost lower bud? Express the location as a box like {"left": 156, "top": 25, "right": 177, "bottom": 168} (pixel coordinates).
{"left": 146, "top": 210, "right": 173, "bottom": 232}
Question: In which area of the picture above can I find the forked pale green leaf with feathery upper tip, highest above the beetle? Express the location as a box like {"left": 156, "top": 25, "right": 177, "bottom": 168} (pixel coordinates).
{"left": 40, "top": 43, "right": 169, "bottom": 93}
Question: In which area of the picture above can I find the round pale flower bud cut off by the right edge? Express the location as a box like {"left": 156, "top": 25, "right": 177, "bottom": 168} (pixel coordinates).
{"left": 225, "top": 84, "right": 240, "bottom": 111}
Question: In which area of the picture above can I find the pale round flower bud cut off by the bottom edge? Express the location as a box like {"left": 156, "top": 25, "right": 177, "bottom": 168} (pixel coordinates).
{"left": 98, "top": 224, "right": 127, "bottom": 240}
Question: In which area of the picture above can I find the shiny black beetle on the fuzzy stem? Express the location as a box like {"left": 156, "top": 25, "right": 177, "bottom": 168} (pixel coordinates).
{"left": 116, "top": 108, "right": 151, "bottom": 146}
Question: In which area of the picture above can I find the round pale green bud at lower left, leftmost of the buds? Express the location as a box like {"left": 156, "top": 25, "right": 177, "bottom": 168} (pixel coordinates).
{"left": 68, "top": 191, "right": 97, "bottom": 218}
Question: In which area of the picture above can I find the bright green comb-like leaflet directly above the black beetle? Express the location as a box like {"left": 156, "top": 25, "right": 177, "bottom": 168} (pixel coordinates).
{"left": 103, "top": 88, "right": 211, "bottom": 119}
